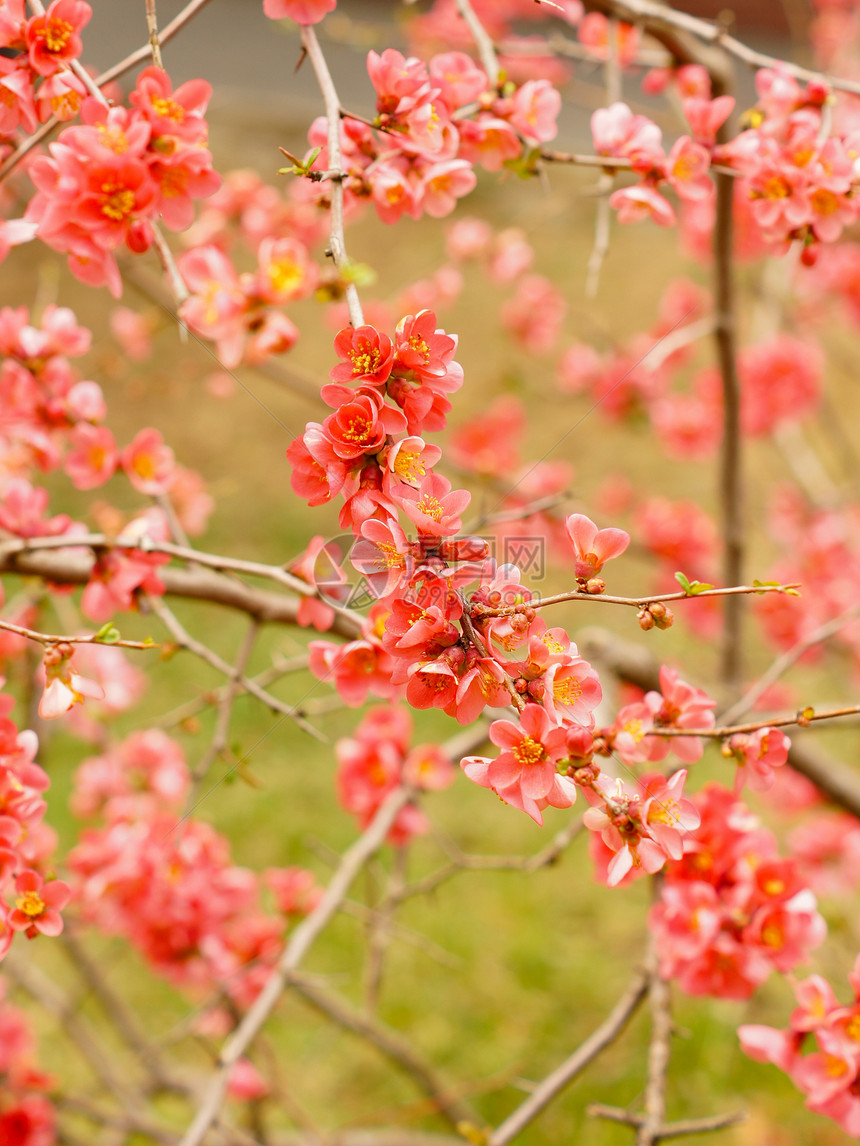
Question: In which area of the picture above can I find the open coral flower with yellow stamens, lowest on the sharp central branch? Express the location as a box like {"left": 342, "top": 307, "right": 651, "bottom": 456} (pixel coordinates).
{"left": 488, "top": 705, "right": 573, "bottom": 800}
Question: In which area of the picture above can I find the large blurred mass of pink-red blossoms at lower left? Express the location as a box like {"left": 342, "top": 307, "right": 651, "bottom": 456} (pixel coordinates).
{"left": 69, "top": 729, "right": 319, "bottom": 1008}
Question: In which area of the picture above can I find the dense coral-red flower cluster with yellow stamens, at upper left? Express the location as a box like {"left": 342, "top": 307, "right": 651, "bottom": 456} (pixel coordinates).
{"left": 25, "top": 67, "right": 220, "bottom": 296}
